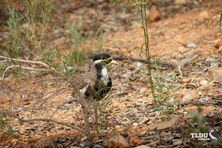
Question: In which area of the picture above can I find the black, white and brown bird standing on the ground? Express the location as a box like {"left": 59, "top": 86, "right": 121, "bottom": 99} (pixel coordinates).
{"left": 72, "top": 53, "right": 118, "bottom": 101}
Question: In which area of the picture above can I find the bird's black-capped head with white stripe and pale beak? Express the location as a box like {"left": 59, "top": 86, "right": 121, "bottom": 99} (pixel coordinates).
{"left": 93, "top": 53, "right": 118, "bottom": 66}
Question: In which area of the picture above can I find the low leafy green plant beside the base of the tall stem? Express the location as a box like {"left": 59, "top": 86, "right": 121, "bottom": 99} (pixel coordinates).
{"left": 151, "top": 58, "right": 181, "bottom": 119}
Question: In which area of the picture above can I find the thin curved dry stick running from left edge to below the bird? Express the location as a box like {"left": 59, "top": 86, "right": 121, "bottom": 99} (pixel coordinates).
{"left": 0, "top": 111, "right": 87, "bottom": 135}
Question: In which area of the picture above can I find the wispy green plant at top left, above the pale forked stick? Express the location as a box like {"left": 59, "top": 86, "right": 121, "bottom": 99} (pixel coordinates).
{"left": 5, "top": 0, "right": 53, "bottom": 57}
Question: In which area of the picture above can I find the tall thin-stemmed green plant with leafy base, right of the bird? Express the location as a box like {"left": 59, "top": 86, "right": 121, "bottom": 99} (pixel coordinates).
{"left": 131, "top": 0, "right": 180, "bottom": 119}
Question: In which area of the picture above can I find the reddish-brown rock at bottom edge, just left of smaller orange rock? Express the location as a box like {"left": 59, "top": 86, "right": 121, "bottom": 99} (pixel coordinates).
{"left": 108, "top": 135, "right": 129, "bottom": 148}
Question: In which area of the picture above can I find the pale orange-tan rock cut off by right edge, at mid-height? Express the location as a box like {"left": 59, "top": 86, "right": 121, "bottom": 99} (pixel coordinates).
{"left": 208, "top": 67, "right": 222, "bottom": 82}
